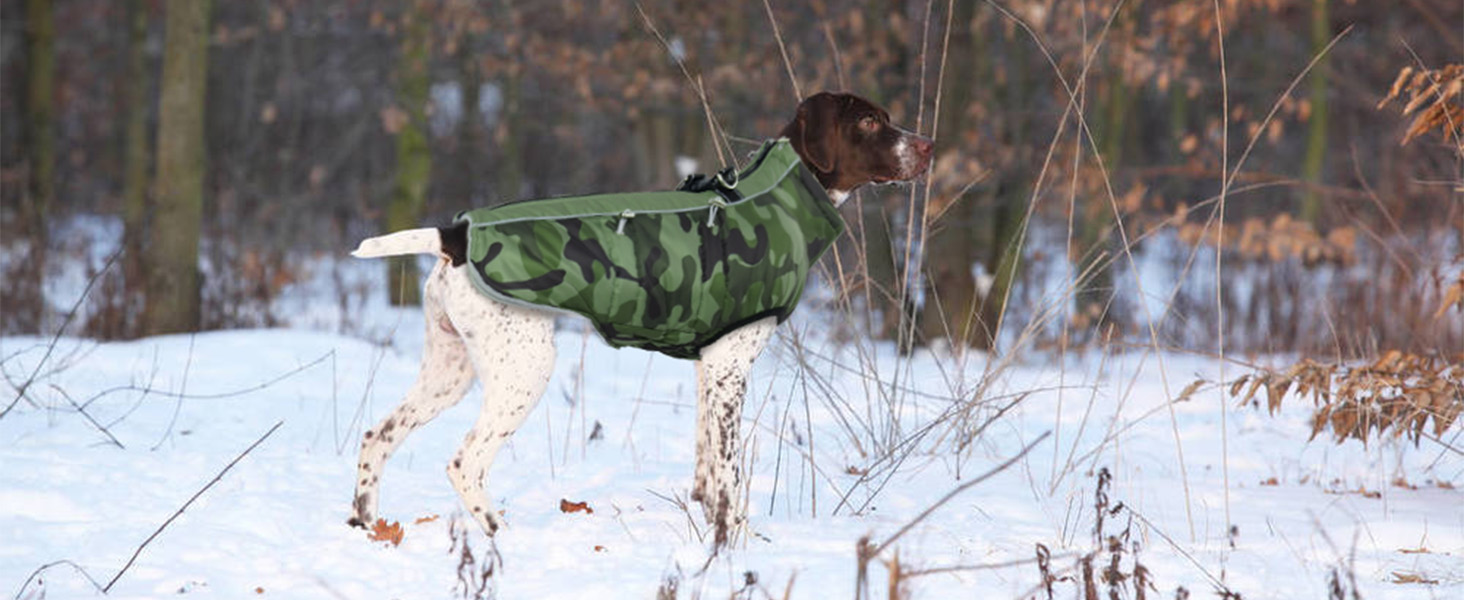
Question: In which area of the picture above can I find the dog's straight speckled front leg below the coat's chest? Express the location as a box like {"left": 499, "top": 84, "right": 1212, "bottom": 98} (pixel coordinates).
{"left": 691, "top": 318, "right": 777, "bottom": 546}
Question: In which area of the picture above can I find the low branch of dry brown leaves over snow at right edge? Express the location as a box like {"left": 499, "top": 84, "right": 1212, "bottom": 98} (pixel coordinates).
{"left": 1230, "top": 350, "right": 1464, "bottom": 445}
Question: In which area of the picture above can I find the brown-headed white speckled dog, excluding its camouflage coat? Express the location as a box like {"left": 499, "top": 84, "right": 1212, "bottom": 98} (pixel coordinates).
{"left": 348, "top": 92, "right": 933, "bottom": 546}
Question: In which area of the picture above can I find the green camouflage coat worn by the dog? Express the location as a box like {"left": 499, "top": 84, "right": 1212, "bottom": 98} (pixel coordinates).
{"left": 454, "top": 139, "right": 843, "bottom": 359}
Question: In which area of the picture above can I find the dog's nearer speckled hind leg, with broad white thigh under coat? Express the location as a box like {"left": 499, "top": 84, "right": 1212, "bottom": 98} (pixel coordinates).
{"left": 436, "top": 274, "right": 556, "bottom": 536}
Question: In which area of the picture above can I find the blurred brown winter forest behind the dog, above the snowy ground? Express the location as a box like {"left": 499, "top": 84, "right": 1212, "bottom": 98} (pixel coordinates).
{"left": 0, "top": 0, "right": 1464, "bottom": 357}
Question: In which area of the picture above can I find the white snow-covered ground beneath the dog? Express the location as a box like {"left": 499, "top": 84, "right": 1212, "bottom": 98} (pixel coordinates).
{"left": 0, "top": 259, "right": 1464, "bottom": 600}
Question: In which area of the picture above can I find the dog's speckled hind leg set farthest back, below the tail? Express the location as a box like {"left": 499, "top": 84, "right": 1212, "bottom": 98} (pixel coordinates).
{"left": 347, "top": 262, "right": 473, "bottom": 527}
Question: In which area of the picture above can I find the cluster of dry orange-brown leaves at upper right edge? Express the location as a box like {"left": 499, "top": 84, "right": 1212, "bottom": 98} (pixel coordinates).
{"left": 1378, "top": 64, "right": 1464, "bottom": 145}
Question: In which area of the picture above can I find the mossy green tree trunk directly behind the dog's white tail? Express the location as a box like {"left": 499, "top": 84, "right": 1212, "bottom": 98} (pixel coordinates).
{"left": 386, "top": 10, "right": 432, "bottom": 306}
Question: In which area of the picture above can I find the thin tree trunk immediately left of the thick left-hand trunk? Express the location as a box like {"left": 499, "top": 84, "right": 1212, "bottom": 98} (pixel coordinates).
{"left": 122, "top": 0, "right": 149, "bottom": 337}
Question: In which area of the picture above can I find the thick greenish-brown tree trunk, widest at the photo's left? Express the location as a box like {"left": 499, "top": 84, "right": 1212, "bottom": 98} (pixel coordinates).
{"left": 142, "top": 0, "right": 212, "bottom": 335}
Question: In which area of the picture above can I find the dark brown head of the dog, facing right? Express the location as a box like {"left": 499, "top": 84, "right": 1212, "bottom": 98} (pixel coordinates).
{"left": 782, "top": 92, "right": 935, "bottom": 202}
